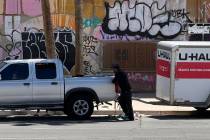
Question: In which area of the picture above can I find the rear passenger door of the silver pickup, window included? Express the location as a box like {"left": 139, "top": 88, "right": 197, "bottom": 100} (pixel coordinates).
{"left": 33, "top": 62, "right": 61, "bottom": 104}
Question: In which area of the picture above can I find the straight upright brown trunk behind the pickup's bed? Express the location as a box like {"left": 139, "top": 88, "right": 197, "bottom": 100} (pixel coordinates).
{"left": 74, "top": 0, "right": 82, "bottom": 75}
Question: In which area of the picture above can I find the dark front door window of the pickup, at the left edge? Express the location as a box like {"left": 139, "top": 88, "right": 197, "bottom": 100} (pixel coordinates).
{"left": 0, "top": 63, "right": 29, "bottom": 80}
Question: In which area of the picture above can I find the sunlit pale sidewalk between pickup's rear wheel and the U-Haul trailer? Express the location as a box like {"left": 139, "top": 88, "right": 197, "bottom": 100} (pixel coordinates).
{"left": 94, "top": 93, "right": 195, "bottom": 115}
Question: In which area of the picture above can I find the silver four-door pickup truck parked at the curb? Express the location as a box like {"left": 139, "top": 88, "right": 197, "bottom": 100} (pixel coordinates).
{"left": 0, "top": 59, "right": 117, "bottom": 119}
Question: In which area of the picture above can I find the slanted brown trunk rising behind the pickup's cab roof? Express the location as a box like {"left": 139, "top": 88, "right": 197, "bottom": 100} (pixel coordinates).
{"left": 41, "top": 0, "right": 55, "bottom": 58}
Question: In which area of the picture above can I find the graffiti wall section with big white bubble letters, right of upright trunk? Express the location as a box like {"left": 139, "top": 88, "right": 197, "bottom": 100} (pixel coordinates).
{"left": 82, "top": 0, "right": 192, "bottom": 74}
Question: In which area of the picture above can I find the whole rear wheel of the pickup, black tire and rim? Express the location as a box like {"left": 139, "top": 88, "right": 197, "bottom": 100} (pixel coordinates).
{"left": 65, "top": 95, "right": 94, "bottom": 119}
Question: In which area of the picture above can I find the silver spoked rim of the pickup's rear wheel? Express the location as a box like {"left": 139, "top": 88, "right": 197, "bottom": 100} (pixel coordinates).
{"left": 73, "top": 100, "right": 89, "bottom": 116}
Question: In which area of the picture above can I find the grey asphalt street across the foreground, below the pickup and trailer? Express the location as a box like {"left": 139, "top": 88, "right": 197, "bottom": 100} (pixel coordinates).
{"left": 0, "top": 112, "right": 210, "bottom": 140}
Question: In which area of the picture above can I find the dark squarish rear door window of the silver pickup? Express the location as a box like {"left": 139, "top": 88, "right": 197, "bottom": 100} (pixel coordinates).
{"left": 35, "top": 63, "right": 56, "bottom": 79}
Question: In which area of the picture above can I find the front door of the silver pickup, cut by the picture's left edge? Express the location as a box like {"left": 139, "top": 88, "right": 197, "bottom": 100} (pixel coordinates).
{"left": 0, "top": 63, "right": 32, "bottom": 105}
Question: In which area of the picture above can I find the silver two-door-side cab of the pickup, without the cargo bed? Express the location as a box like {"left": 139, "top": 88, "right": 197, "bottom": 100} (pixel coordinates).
{"left": 0, "top": 60, "right": 63, "bottom": 106}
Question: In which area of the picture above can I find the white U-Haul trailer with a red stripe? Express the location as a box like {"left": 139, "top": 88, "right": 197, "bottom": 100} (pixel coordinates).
{"left": 156, "top": 41, "right": 210, "bottom": 110}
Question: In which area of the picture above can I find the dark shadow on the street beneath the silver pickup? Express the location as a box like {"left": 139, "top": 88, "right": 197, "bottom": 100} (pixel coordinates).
{"left": 0, "top": 116, "right": 128, "bottom": 126}
